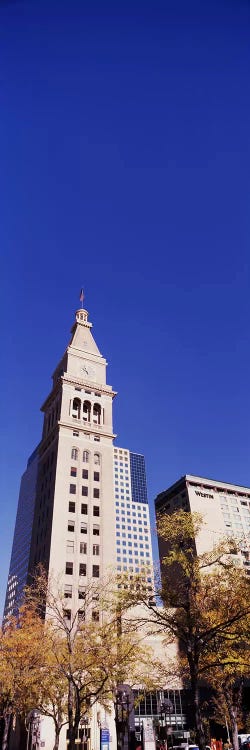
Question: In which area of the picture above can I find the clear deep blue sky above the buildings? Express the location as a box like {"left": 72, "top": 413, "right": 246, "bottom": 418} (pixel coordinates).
{"left": 0, "top": 0, "right": 250, "bottom": 609}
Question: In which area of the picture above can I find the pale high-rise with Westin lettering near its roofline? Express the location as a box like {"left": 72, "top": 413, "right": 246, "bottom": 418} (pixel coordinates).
{"left": 155, "top": 474, "right": 250, "bottom": 575}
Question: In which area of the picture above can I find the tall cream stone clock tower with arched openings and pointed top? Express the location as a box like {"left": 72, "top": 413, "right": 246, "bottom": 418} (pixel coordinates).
{"left": 29, "top": 309, "right": 116, "bottom": 611}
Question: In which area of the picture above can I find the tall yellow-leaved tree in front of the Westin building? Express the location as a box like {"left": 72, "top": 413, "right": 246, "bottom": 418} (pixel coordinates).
{"left": 119, "top": 510, "right": 250, "bottom": 750}
